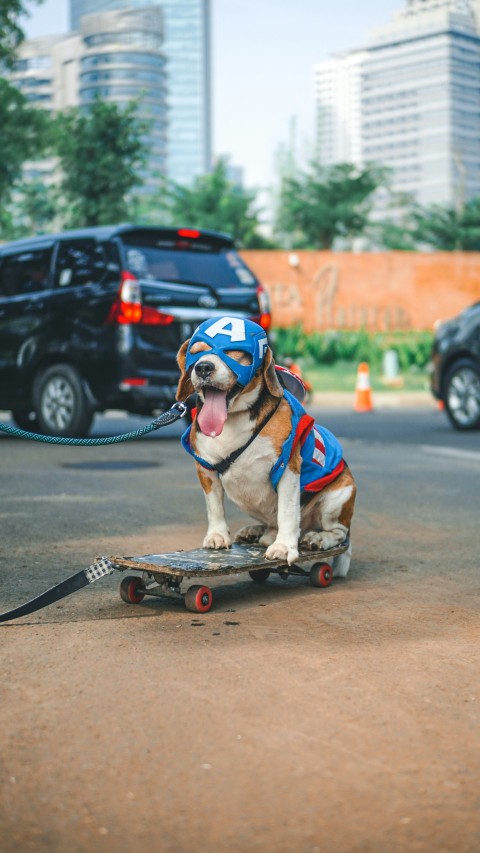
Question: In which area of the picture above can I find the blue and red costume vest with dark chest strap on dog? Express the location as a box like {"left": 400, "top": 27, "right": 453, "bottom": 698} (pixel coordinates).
{"left": 181, "top": 389, "right": 345, "bottom": 493}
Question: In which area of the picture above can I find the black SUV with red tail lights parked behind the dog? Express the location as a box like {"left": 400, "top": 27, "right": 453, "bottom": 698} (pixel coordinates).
{"left": 0, "top": 225, "right": 270, "bottom": 436}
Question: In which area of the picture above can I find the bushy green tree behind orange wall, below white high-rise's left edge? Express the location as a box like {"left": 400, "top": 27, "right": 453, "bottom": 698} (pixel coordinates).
{"left": 276, "top": 162, "right": 386, "bottom": 249}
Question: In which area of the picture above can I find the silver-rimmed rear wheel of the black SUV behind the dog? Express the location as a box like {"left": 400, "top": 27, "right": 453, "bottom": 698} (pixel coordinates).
{"left": 33, "top": 364, "right": 94, "bottom": 438}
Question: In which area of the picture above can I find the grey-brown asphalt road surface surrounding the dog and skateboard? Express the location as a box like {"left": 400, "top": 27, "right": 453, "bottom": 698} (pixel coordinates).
{"left": 0, "top": 407, "right": 480, "bottom": 853}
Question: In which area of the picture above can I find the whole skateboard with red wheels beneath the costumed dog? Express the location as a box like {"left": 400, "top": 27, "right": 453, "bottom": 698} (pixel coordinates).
{"left": 108, "top": 541, "right": 349, "bottom": 613}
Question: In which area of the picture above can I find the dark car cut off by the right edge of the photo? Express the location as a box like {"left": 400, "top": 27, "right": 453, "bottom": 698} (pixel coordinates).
{"left": 432, "top": 302, "right": 480, "bottom": 430}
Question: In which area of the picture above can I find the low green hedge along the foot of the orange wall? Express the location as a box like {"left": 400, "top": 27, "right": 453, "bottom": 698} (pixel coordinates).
{"left": 272, "top": 326, "right": 433, "bottom": 370}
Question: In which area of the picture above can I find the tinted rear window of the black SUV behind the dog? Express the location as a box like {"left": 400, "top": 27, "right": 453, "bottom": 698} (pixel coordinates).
{"left": 123, "top": 238, "right": 257, "bottom": 288}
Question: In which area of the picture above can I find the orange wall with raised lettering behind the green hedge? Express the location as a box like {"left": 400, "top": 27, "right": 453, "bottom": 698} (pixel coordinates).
{"left": 241, "top": 251, "right": 480, "bottom": 332}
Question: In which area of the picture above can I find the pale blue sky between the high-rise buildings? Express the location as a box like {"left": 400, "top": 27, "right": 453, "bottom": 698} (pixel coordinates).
{"left": 24, "top": 0, "right": 404, "bottom": 188}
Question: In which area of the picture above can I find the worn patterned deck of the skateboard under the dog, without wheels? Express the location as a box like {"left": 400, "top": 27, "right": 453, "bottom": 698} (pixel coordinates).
{"left": 108, "top": 542, "right": 348, "bottom": 578}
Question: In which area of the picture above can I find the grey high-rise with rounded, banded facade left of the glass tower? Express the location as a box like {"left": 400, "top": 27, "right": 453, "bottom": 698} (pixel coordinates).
{"left": 12, "top": 6, "right": 167, "bottom": 193}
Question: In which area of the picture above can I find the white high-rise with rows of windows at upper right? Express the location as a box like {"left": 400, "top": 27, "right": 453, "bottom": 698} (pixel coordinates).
{"left": 316, "top": 0, "right": 480, "bottom": 204}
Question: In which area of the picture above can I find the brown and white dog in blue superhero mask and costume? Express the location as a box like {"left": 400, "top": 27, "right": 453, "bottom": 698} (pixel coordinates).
{"left": 177, "top": 317, "right": 356, "bottom": 577}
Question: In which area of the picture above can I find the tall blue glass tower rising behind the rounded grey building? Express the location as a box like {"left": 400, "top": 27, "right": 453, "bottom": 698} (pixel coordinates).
{"left": 70, "top": 0, "right": 212, "bottom": 184}
